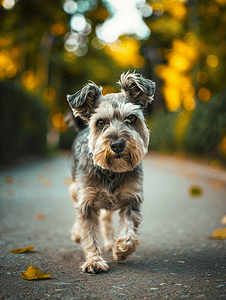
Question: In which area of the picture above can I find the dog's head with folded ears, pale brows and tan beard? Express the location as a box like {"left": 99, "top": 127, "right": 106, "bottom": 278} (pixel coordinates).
{"left": 67, "top": 72, "right": 155, "bottom": 172}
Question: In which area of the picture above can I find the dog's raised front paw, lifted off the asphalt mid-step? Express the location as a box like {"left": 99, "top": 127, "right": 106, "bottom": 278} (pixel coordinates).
{"left": 112, "top": 237, "right": 141, "bottom": 261}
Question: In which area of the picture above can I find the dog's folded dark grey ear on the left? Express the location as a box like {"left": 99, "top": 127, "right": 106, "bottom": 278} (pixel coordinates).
{"left": 67, "top": 82, "right": 102, "bottom": 120}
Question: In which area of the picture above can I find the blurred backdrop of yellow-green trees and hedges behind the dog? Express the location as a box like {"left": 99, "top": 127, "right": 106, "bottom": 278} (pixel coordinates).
{"left": 0, "top": 0, "right": 226, "bottom": 167}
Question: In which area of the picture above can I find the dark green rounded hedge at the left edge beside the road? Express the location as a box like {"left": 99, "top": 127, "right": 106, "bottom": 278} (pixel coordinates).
{"left": 0, "top": 82, "right": 47, "bottom": 165}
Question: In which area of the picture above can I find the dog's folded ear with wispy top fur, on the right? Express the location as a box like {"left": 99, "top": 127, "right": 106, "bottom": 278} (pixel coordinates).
{"left": 118, "top": 72, "right": 156, "bottom": 108}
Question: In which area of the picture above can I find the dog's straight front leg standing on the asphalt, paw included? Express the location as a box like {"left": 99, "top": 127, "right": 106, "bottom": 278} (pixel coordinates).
{"left": 77, "top": 206, "right": 109, "bottom": 274}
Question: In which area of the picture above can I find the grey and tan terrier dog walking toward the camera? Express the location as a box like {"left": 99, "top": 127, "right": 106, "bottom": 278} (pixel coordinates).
{"left": 67, "top": 72, "right": 155, "bottom": 273}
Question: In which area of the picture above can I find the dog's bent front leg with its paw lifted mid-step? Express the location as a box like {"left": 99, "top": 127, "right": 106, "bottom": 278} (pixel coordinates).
{"left": 113, "top": 203, "right": 141, "bottom": 261}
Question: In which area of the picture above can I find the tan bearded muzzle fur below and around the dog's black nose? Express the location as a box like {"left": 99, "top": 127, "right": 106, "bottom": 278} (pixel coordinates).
{"left": 93, "top": 140, "right": 147, "bottom": 173}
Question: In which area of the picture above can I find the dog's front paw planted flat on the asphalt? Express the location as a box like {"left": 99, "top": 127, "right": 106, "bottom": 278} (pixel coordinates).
{"left": 81, "top": 256, "right": 110, "bottom": 274}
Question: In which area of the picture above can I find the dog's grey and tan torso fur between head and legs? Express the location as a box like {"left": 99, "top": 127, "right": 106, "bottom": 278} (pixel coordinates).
{"left": 73, "top": 128, "right": 143, "bottom": 210}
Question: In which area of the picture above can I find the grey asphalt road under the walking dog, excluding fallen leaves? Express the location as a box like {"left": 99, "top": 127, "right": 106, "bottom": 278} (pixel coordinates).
{"left": 0, "top": 153, "right": 226, "bottom": 300}
